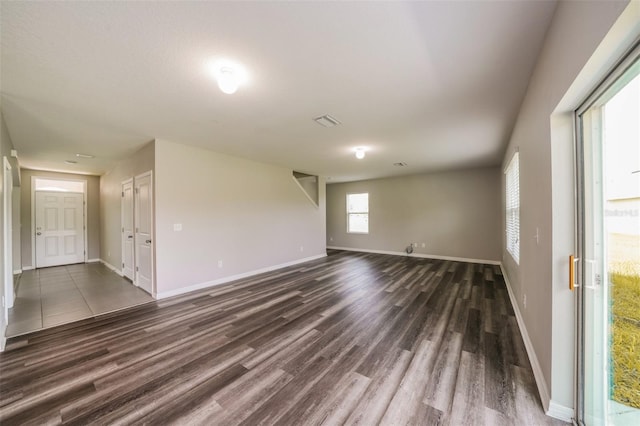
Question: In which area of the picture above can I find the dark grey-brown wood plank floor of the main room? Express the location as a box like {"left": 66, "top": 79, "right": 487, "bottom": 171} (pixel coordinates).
{"left": 0, "top": 251, "right": 561, "bottom": 425}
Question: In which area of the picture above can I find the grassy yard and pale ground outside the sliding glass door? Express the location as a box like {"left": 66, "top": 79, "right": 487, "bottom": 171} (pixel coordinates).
{"left": 609, "top": 234, "right": 640, "bottom": 408}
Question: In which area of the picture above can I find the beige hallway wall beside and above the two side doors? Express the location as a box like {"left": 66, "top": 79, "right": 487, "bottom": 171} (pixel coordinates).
{"left": 100, "top": 142, "right": 155, "bottom": 271}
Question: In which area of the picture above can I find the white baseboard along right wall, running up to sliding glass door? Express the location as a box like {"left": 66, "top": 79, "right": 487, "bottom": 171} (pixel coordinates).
{"left": 500, "top": 264, "right": 574, "bottom": 423}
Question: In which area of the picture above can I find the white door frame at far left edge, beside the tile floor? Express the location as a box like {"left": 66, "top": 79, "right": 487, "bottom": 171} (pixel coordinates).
{"left": 2, "top": 156, "right": 15, "bottom": 316}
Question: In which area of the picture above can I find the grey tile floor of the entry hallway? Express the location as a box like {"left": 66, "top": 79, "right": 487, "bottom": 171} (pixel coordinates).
{"left": 7, "top": 263, "right": 154, "bottom": 337}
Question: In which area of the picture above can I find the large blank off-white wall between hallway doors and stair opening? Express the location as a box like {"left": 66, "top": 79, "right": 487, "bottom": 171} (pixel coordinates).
{"left": 155, "top": 140, "right": 326, "bottom": 297}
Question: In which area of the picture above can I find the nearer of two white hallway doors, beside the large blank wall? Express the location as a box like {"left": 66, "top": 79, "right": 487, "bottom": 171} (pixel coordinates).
{"left": 133, "top": 172, "right": 153, "bottom": 294}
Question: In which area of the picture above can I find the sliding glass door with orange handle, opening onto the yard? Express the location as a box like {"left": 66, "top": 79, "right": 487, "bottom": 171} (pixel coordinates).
{"left": 576, "top": 48, "right": 640, "bottom": 426}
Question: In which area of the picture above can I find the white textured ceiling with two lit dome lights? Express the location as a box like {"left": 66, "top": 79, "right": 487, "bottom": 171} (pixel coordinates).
{"left": 0, "top": 1, "right": 555, "bottom": 182}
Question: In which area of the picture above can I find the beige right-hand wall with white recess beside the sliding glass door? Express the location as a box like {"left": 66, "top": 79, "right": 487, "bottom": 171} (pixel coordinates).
{"left": 502, "top": 1, "right": 638, "bottom": 413}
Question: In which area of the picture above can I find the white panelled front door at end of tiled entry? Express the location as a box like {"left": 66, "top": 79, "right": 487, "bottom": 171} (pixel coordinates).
{"left": 35, "top": 191, "right": 84, "bottom": 268}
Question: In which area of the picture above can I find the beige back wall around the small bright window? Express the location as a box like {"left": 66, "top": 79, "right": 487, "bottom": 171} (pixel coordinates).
{"left": 327, "top": 167, "right": 501, "bottom": 261}
